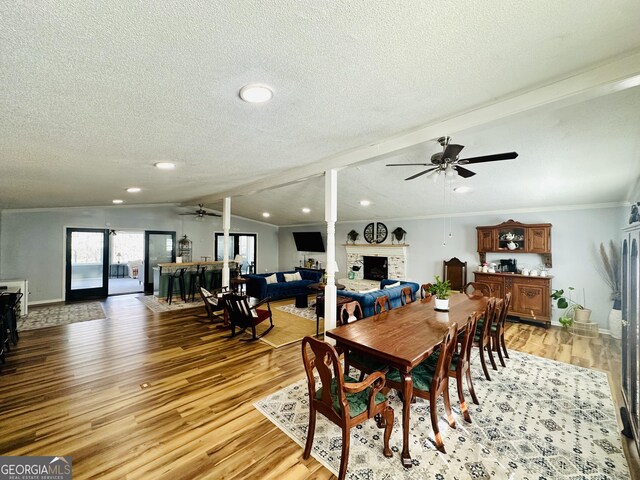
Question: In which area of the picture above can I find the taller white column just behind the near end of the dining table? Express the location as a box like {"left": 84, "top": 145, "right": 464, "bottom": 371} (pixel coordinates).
{"left": 324, "top": 169, "right": 338, "bottom": 343}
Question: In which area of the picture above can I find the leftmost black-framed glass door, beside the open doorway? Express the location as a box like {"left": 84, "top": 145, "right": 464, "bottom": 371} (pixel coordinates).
{"left": 65, "top": 228, "right": 109, "bottom": 301}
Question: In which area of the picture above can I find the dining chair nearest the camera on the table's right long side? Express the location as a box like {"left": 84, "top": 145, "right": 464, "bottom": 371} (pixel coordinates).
{"left": 385, "top": 323, "right": 458, "bottom": 453}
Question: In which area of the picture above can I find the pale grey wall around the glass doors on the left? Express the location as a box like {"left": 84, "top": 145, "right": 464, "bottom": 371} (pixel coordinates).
{"left": 0, "top": 205, "right": 278, "bottom": 303}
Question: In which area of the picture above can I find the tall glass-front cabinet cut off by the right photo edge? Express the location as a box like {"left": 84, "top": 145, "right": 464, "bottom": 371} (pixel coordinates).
{"left": 621, "top": 223, "right": 640, "bottom": 453}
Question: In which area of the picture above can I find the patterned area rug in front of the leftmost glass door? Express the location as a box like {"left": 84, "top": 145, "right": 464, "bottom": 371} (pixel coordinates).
{"left": 18, "top": 302, "right": 106, "bottom": 331}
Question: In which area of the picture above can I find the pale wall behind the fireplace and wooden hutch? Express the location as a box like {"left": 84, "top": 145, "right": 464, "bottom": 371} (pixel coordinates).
{"left": 280, "top": 207, "right": 629, "bottom": 329}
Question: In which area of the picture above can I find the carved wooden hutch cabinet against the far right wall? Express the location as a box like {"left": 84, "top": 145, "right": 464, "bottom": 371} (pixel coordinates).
{"left": 474, "top": 220, "right": 552, "bottom": 327}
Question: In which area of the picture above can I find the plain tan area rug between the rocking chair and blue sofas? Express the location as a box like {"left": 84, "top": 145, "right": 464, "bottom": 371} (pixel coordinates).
{"left": 257, "top": 300, "right": 324, "bottom": 348}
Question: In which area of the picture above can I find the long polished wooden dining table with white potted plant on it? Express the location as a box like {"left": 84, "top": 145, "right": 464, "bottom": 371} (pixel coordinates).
{"left": 326, "top": 293, "right": 488, "bottom": 468}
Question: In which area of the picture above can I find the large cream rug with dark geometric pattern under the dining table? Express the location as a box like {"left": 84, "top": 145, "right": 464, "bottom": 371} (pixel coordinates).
{"left": 254, "top": 351, "right": 629, "bottom": 480}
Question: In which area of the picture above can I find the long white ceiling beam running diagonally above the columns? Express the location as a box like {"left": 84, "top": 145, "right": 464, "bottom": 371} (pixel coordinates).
{"left": 184, "top": 49, "right": 640, "bottom": 205}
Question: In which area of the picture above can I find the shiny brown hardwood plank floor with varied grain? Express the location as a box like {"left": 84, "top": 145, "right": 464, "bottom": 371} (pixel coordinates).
{"left": 0, "top": 296, "right": 640, "bottom": 479}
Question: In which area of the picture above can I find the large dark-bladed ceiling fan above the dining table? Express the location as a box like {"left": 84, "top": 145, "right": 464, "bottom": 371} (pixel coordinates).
{"left": 387, "top": 137, "right": 518, "bottom": 180}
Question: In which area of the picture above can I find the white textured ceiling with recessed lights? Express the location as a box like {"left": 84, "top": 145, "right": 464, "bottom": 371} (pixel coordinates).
{"left": 0, "top": 0, "right": 640, "bottom": 225}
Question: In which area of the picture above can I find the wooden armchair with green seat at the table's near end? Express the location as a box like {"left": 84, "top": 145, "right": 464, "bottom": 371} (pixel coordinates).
{"left": 302, "top": 337, "right": 394, "bottom": 480}
